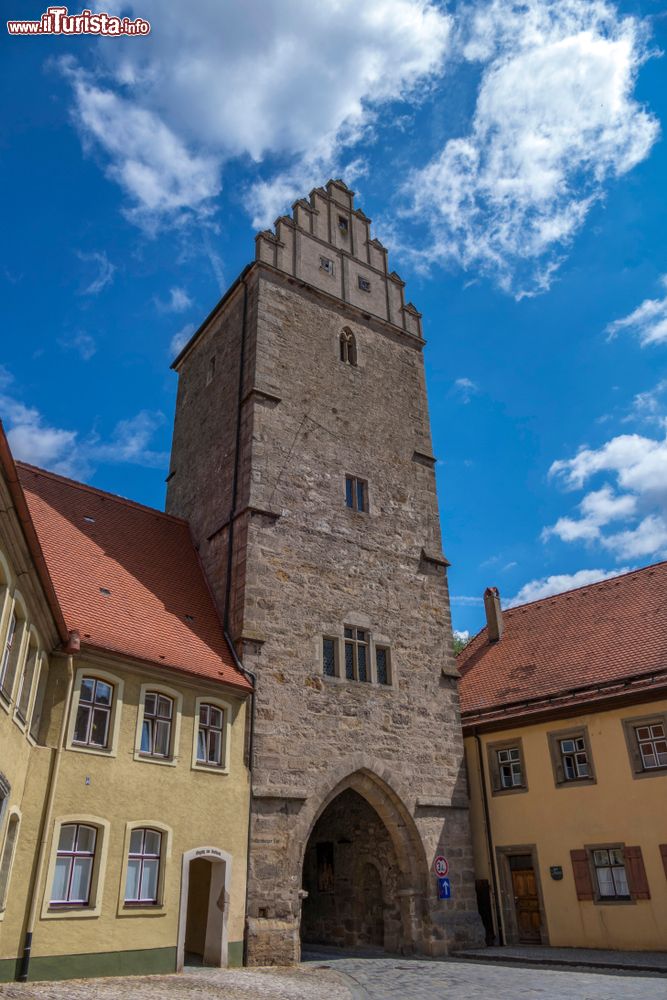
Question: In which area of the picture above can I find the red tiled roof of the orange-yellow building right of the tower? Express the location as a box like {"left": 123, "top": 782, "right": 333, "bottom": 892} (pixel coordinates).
{"left": 457, "top": 562, "right": 667, "bottom": 715}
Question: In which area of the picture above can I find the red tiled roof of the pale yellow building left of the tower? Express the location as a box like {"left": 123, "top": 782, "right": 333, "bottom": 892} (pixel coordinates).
{"left": 16, "top": 462, "right": 250, "bottom": 689}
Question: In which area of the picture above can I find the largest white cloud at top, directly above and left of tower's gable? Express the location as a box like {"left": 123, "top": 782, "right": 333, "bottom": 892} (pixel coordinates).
{"left": 65, "top": 0, "right": 451, "bottom": 224}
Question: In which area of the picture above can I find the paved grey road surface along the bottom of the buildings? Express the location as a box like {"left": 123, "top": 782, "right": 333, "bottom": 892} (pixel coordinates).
{"left": 0, "top": 955, "right": 667, "bottom": 1000}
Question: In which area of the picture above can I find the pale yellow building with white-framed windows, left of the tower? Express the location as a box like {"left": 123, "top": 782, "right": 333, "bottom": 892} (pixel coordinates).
{"left": 0, "top": 425, "right": 251, "bottom": 980}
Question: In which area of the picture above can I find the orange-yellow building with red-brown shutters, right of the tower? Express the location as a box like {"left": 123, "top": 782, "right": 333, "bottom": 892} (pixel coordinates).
{"left": 458, "top": 576, "right": 667, "bottom": 950}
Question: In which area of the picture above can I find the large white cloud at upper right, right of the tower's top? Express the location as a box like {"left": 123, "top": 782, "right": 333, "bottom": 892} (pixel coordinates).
{"left": 406, "top": 0, "right": 658, "bottom": 297}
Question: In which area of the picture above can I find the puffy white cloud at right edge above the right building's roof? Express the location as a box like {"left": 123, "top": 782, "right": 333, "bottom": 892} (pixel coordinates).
{"left": 542, "top": 424, "right": 667, "bottom": 559}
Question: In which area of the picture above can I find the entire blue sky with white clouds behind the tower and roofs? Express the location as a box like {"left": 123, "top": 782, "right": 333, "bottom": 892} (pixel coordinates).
{"left": 0, "top": 0, "right": 667, "bottom": 631}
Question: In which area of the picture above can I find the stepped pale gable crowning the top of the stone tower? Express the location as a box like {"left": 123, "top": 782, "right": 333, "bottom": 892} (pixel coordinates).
{"left": 255, "top": 180, "right": 422, "bottom": 338}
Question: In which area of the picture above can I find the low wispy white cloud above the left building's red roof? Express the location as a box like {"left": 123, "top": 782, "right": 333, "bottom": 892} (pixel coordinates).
{"left": 0, "top": 366, "right": 169, "bottom": 479}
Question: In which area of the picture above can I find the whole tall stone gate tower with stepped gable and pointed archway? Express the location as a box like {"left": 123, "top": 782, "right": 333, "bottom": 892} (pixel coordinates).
{"left": 167, "top": 180, "right": 482, "bottom": 964}
